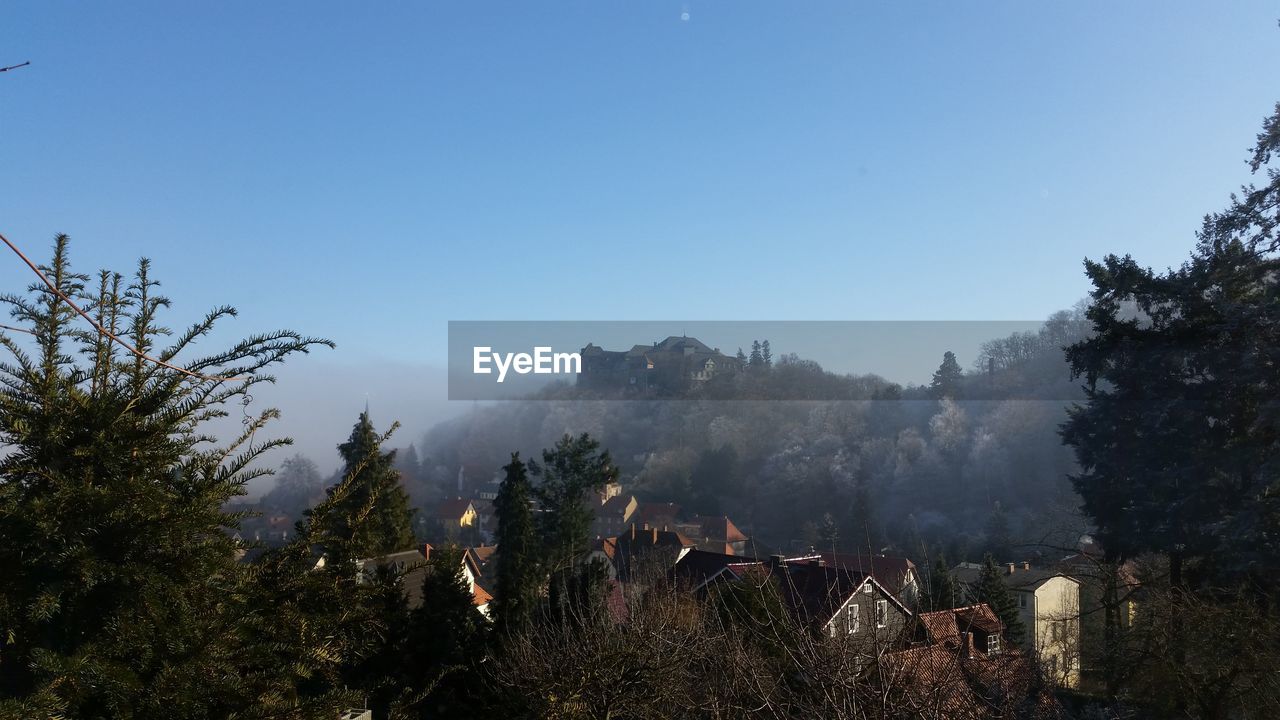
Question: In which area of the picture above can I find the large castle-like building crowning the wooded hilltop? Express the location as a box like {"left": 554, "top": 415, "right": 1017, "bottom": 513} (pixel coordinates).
{"left": 577, "top": 336, "right": 742, "bottom": 392}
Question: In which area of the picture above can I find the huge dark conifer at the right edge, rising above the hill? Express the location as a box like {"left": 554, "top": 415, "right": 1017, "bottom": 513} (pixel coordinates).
{"left": 1062, "top": 104, "right": 1280, "bottom": 589}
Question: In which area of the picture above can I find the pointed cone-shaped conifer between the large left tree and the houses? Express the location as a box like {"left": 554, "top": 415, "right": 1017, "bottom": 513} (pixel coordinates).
{"left": 312, "top": 410, "right": 413, "bottom": 560}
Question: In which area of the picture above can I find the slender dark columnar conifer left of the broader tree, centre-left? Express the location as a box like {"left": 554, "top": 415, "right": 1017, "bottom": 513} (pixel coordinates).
{"left": 493, "top": 452, "right": 541, "bottom": 634}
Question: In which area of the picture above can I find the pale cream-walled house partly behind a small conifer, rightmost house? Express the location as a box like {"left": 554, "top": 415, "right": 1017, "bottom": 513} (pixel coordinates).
{"left": 952, "top": 562, "right": 1080, "bottom": 688}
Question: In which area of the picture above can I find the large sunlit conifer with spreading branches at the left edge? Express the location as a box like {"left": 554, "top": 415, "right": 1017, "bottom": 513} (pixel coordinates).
{"left": 0, "top": 236, "right": 332, "bottom": 717}
